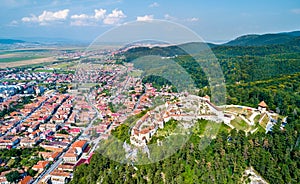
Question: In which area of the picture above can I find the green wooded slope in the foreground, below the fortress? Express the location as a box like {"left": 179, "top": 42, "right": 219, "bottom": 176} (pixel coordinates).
{"left": 71, "top": 119, "right": 300, "bottom": 184}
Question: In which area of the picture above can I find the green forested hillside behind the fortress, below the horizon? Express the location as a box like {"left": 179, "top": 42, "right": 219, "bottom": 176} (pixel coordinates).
{"left": 120, "top": 32, "right": 300, "bottom": 115}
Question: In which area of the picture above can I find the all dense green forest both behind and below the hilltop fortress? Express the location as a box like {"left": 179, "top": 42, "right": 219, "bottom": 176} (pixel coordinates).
{"left": 71, "top": 34, "right": 300, "bottom": 184}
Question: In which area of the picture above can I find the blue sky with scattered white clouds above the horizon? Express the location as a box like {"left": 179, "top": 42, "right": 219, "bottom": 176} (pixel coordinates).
{"left": 0, "top": 0, "right": 300, "bottom": 41}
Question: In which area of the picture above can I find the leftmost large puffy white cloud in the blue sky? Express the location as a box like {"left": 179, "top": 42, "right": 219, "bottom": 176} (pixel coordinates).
{"left": 21, "top": 9, "right": 70, "bottom": 25}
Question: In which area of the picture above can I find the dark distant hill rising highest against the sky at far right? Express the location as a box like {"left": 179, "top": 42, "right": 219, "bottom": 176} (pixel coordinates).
{"left": 224, "top": 31, "right": 300, "bottom": 46}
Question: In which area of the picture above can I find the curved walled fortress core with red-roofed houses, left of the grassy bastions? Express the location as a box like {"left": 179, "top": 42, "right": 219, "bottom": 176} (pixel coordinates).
{"left": 130, "top": 95, "right": 232, "bottom": 147}
